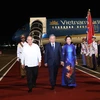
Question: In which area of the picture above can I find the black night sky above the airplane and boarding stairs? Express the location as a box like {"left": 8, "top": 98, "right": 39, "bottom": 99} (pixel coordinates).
{"left": 0, "top": 1, "right": 100, "bottom": 43}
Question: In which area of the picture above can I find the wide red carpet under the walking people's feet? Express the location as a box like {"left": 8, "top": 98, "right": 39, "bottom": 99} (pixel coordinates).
{"left": 0, "top": 63, "right": 100, "bottom": 100}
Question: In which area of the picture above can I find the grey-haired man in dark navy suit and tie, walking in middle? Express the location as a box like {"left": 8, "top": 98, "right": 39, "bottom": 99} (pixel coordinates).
{"left": 44, "top": 34, "right": 64, "bottom": 90}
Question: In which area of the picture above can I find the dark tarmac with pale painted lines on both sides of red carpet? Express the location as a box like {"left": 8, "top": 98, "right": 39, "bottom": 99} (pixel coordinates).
{"left": 0, "top": 48, "right": 100, "bottom": 79}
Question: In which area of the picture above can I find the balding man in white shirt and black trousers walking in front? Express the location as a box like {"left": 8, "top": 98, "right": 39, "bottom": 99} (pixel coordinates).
{"left": 21, "top": 36, "right": 41, "bottom": 92}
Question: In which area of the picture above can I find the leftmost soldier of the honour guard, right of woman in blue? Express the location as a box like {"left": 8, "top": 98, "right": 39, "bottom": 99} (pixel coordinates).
{"left": 81, "top": 38, "right": 86, "bottom": 66}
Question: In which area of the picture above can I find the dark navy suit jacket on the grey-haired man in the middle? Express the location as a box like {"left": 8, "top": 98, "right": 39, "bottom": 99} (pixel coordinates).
{"left": 44, "top": 42, "right": 62, "bottom": 66}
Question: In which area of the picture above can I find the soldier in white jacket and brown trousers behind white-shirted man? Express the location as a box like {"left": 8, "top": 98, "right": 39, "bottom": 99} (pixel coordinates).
{"left": 17, "top": 35, "right": 27, "bottom": 78}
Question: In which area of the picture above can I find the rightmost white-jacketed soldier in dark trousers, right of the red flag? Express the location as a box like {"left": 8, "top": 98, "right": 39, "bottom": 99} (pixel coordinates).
{"left": 90, "top": 36, "right": 98, "bottom": 70}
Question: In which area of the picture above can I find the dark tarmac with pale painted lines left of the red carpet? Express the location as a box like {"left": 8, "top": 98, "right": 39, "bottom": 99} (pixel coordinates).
{"left": 0, "top": 48, "right": 16, "bottom": 78}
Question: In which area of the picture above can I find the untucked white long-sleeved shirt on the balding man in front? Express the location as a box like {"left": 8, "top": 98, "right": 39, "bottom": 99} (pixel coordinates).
{"left": 21, "top": 43, "right": 41, "bottom": 67}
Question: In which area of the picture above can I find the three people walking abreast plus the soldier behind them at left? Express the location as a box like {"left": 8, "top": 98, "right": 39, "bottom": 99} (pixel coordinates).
{"left": 17, "top": 34, "right": 77, "bottom": 92}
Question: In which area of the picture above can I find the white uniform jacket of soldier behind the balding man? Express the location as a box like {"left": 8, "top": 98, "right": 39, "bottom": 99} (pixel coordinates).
{"left": 17, "top": 42, "right": 27, "bottom": 60}
